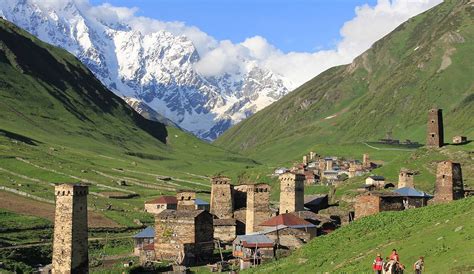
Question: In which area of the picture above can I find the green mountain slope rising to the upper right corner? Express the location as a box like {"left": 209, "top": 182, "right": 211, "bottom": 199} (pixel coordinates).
{"left": 215, "top": 0, "right": 474, "bottom": 162}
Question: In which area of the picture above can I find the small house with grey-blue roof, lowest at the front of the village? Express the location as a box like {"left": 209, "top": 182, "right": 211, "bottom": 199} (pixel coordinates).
{"left": 232, "top": 234, "right": 275, "bottom": 269}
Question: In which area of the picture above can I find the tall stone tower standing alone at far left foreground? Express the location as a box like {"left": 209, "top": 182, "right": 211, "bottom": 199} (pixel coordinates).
{"left": 52, "top": 184, "right": 89, "bottom": 274}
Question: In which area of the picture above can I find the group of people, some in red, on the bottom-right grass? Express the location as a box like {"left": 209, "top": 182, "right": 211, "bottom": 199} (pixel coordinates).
{"left": 372, "top": 249, "right": 425, "bottom": 274}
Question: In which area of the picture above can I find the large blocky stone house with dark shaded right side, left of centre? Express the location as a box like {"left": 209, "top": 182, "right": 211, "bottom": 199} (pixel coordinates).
{"left": 154, "top": 210, "right": 214, "bottom": 266}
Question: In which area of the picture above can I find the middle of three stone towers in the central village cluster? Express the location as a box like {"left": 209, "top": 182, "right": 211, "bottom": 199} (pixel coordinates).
{"left": 245, "top": 184, "right": 271, "bottom": 234}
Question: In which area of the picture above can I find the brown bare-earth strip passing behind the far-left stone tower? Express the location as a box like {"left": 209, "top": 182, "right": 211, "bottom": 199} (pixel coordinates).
{"left": 0, "top": 191, "right": 120, "bottom": 227}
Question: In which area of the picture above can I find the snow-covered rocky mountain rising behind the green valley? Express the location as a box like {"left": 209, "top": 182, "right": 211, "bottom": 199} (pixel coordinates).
{"left": 0, "top": 0, "right": 288, "bottom": 140}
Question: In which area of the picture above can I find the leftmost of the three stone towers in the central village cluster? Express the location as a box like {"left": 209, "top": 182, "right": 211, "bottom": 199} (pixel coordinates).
{"left": 211, "top": 176, "right": 234, "bottom": 219}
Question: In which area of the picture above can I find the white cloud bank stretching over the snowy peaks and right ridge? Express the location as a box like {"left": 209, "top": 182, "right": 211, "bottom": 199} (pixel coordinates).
{"left": 39, "top": 0, "right": 442, "bottom": 88}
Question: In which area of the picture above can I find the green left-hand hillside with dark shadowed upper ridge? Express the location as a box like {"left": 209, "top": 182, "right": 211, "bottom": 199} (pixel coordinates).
{"left": 0, "top": 19, "right": 256, "bottom": 229}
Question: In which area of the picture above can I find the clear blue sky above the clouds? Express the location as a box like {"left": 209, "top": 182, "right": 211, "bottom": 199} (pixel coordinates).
{"left": 90, "top": 0, "right": 376, "bottom": 52}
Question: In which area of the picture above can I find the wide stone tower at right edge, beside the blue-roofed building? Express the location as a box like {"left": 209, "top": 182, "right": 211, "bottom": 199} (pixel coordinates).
{"left": 433, "top": 161, "right": 464, "bottom": 203}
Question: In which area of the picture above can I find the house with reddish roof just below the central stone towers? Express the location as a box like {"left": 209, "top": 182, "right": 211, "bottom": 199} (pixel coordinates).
{"left": 258, "top": 213, "right": 317, "bottom": 249}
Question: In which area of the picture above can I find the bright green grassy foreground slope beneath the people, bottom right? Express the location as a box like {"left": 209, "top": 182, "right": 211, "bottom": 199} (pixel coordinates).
{"left": 253, "top": 198, "right": 474, "bottom": 273}
